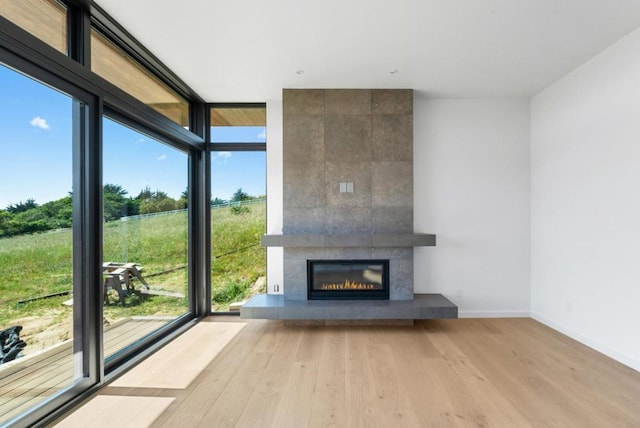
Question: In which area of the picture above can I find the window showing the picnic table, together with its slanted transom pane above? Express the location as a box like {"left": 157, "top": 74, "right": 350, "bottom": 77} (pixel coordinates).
{"left": 90, "top": 20, "right": 199, "bottom": 363}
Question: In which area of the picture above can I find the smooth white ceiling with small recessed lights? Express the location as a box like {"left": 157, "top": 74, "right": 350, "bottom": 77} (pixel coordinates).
{"left": 97, "top": 0, "right": 640, "bottom": 102}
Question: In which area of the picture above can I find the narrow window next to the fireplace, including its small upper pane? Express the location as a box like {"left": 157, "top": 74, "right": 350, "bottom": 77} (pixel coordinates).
{"left": 210, "top": 104, "right": 267, "bottom": 311}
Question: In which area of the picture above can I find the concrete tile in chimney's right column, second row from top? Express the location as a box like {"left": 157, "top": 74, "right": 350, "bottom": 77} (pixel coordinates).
{"left": 371, "top": 114, "right": 413, "bottom": 161}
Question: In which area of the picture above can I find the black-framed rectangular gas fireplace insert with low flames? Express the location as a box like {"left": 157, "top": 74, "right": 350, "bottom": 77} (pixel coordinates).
{"left": 307, "top": 260, "right": 389, "bottom": 300}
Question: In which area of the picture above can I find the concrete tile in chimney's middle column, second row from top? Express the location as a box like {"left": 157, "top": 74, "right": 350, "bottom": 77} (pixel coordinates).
{"left": 324, "top": 115, "right": 372, "bottom": 162}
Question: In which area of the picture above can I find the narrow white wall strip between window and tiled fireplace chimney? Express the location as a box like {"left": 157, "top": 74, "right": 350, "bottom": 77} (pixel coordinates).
{"left": 267, "top": 100, "right": 284, "bottom": 294}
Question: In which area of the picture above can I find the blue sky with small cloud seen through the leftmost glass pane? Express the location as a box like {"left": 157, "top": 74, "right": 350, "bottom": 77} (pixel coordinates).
{"left": 0, "top": 66, "right": 72, "bottom": 208}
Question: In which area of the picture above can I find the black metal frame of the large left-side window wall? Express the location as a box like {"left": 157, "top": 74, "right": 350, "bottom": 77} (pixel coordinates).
{"left": 0, "top": 0, "right": 211, "bottom": 426}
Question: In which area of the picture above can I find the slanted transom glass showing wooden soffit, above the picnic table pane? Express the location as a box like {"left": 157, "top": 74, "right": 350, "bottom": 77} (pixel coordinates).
{"left": 91, "top": 30, "right": 189, "bottom": 127}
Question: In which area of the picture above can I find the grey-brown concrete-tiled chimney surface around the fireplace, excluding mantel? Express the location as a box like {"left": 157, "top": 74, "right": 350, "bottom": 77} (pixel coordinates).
{"left": 283, "top": 89, "right": 413, "bottom": 300}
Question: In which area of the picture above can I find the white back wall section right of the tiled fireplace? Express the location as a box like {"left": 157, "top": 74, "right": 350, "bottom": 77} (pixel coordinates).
{"left": 414, "top": 98, "right": 530, "bottom": 316}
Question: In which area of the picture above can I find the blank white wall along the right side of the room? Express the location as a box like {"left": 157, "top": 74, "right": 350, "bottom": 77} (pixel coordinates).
{"left": 531, "top": 30, "right": 640, "bottom": 370}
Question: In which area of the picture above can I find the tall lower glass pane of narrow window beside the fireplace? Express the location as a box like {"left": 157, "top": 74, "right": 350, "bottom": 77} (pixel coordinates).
{"left": 211, "top": 152, "right": 266, "bottom": 311}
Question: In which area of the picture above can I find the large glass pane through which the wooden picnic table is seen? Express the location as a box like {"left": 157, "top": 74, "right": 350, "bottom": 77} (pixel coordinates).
{"left": 103, "top": 118, "right": 188, "bottom": 358}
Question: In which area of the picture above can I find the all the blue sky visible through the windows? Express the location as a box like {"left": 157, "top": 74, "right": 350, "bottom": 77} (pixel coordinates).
{"left": 0, "top": 65, "right": 266, "bottom": 208}
